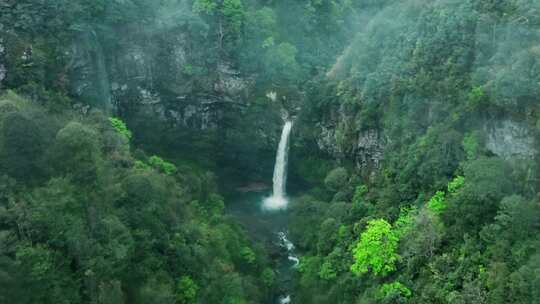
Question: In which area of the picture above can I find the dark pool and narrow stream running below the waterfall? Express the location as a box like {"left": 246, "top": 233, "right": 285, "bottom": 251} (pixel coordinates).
{"left": 227, "top": 192, "right": 299, "bottom": 304}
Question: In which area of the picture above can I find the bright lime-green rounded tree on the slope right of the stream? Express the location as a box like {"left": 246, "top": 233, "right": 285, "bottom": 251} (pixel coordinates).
{"left": 351, "top": 219, "right": 399, "bottom": 276}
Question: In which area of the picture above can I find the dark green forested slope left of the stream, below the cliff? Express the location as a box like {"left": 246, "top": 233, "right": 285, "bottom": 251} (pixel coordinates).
{"left": 0, "top": 93, "right": 275, "bottom": 304}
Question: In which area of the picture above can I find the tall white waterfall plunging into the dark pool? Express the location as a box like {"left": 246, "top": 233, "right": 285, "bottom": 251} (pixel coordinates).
{"left": 263, "top": 119, "right": 293, "bottom": 210}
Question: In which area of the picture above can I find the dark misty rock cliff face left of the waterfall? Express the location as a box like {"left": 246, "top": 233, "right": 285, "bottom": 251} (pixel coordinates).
{"left": 0, "top": 15, "right": 282, "bottom": 178}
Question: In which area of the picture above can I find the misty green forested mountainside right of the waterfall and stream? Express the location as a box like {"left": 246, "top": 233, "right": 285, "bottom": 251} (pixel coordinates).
{"left": 284, "top": 1, "right": 540, "bottom": 304}
